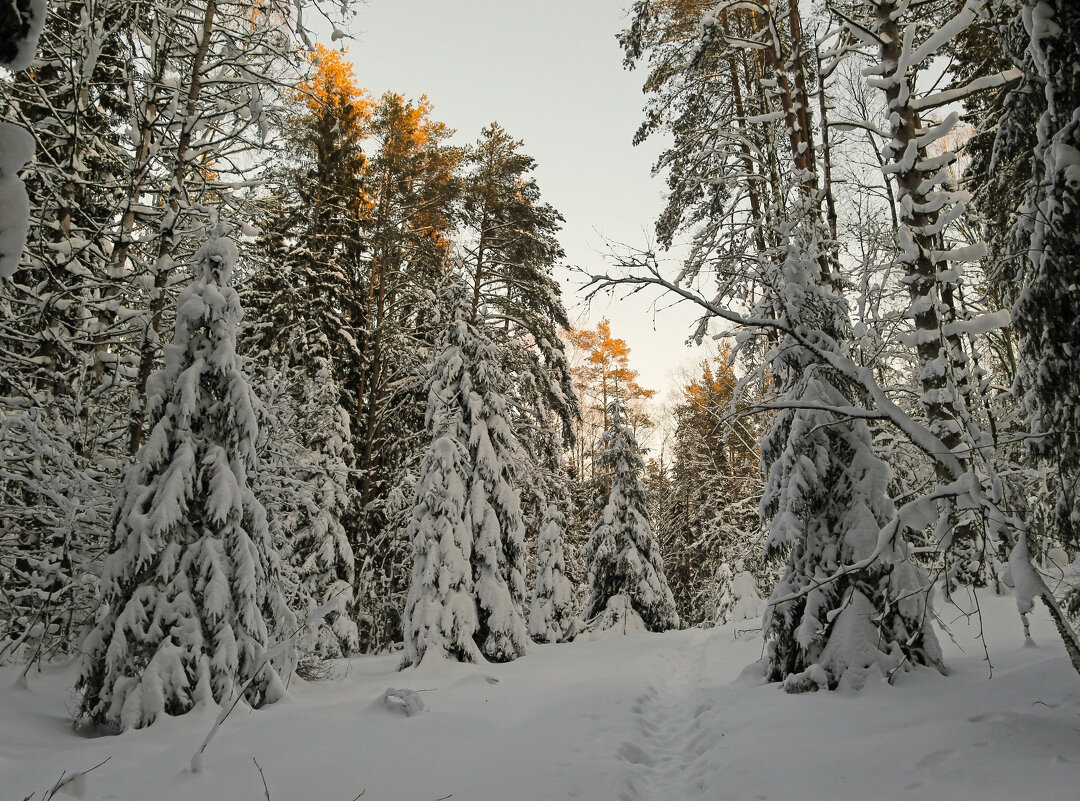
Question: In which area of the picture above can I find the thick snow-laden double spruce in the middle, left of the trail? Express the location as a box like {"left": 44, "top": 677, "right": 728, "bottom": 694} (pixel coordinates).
{"left": 405, "top": 287, "right": 526, "bottom": 665}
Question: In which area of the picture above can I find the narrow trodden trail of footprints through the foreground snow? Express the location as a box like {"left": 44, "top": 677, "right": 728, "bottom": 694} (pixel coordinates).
{"left": 618, "top": 634, "right": 734, "bottom": 801}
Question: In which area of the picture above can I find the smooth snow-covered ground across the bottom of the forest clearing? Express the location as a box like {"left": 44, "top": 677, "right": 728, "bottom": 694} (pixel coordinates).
{"left": 0, "top": 593, "right": 1080, "bottom": 801}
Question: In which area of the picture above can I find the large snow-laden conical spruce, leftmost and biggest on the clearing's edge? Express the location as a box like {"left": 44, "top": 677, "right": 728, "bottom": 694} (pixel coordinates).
{"left": 76, "top": 225, "right": 295, "bottom": 729}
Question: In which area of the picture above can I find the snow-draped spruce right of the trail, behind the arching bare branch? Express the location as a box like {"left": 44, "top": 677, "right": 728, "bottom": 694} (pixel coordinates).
{"left": 761, "top": 226, "right": 942, "bottom": 692}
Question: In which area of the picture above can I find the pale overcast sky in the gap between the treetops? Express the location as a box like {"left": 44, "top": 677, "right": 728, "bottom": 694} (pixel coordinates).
{"left": 349, "top": 0, "right": 694, "bottom": 401}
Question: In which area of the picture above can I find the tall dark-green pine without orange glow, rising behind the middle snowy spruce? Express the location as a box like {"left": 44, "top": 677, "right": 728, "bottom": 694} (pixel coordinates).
{"left": 458, "top": 123, "right": 580, "bottom": 634}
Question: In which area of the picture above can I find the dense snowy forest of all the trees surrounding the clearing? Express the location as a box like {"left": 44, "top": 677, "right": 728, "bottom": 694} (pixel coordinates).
{"left": 0, "top": 0, "right": 1080, "bottom": 727}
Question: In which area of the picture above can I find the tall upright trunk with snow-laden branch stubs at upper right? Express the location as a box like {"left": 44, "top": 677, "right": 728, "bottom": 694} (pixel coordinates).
{"left": 867, "top": 0, "right": 989, "bottom": 586}
